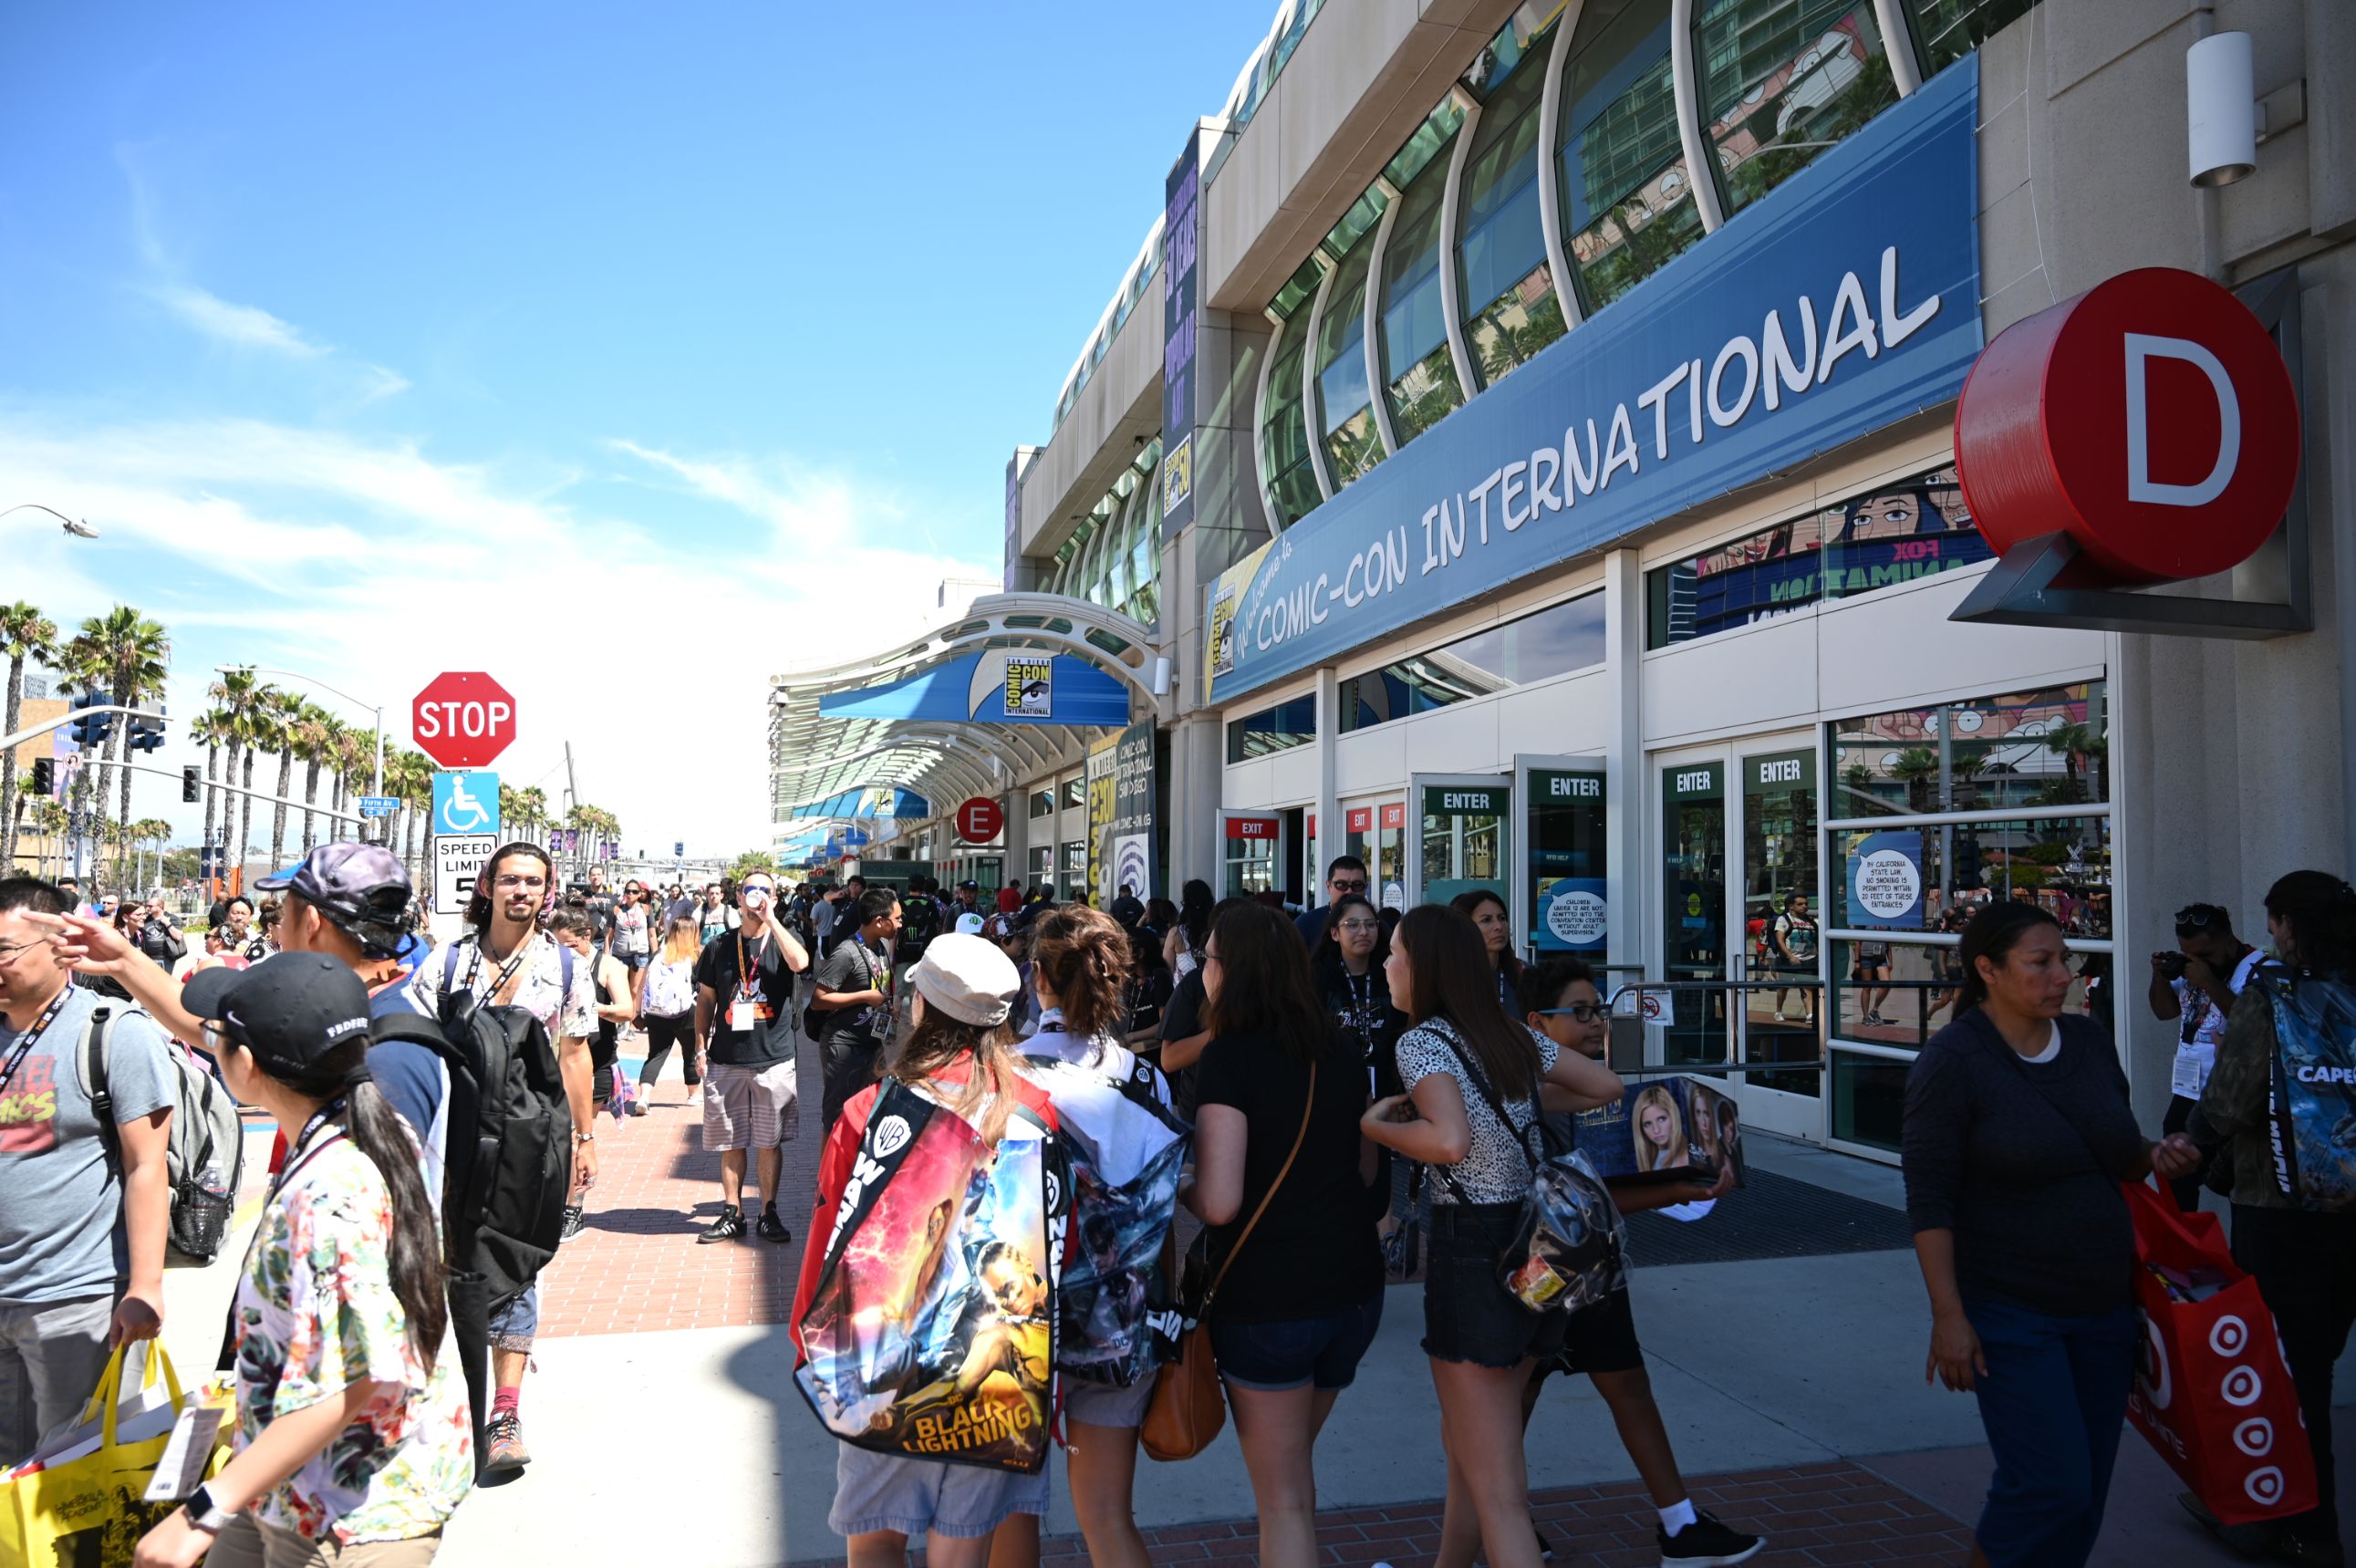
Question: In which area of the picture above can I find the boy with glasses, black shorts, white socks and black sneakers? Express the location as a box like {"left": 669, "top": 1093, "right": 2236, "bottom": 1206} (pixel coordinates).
{"left": 1520, "top": 959, "right": 1767, "bottom": 1563}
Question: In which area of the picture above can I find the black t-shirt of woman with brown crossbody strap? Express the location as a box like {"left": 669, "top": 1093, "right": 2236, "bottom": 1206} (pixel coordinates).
{"left": 1199, "top": 1033, "right": 1383, "bottom": 1324}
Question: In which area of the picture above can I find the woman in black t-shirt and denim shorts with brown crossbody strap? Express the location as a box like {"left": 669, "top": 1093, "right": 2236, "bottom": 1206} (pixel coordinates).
{"left": 1178, "top": 904, "right": 1383, "bottom": 1568}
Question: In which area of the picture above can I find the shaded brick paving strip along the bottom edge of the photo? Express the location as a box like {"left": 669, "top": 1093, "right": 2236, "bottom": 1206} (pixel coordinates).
{"left": 791, "top": 1464, "right": 1972, "bottom": 1568}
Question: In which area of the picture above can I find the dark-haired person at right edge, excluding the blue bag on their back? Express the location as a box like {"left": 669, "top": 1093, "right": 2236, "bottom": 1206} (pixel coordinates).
{"left": 2186, "top": 871, "right": 2356, "bottom": 1563}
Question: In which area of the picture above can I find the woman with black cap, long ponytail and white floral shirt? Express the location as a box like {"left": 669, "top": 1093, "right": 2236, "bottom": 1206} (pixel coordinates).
{"left": 134, "top": 953, "right": 473, "bottom": 1568}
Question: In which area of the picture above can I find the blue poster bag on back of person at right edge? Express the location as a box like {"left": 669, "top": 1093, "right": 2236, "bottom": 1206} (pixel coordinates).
{"left": 2255, "top": 963, "right": 2356, "bottom": 1212}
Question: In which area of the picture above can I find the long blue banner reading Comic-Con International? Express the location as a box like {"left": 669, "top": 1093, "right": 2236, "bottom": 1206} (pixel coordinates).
{"left": 1206, "top": 57, "right": 1981, "bottom": 704}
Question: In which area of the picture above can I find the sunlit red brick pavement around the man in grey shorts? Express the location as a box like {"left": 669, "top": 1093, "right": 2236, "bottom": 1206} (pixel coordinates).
{"left": 540, "top": 1036, "right": 822, "bottom": 1337}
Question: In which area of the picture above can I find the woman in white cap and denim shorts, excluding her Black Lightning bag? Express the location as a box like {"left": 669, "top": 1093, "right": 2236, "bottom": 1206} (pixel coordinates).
{"left": 789, "top": 932, "right": 1055, "bottom": 1568}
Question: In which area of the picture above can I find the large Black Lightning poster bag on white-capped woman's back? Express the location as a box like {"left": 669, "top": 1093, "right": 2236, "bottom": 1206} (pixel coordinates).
{"left": 794, "top": 1078, "right": 1070, "bottom": 1474}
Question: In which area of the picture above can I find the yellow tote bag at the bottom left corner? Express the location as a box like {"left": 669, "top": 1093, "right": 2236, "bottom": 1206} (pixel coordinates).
{"left": 0, "top": 1340, "right": 229, "bottom": 1568}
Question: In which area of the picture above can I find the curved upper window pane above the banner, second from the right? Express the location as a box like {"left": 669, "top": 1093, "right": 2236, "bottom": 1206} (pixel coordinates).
{"left": 1694, "top": 0, "right": 1899, "bottom": 212}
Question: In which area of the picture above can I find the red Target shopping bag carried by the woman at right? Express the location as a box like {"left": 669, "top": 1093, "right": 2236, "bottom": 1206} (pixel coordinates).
{"left": 2127, "top": 1182, "right": 2316, "bottom": 1523}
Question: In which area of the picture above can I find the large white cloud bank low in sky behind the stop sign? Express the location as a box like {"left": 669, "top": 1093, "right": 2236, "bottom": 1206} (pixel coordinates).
{"left": 0, "top": 414, "right": 990, "bottom": 855}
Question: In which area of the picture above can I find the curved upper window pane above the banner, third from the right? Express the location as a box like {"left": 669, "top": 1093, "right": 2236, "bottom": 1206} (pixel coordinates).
{"left": 1557, "top": 0, "right": 1701, "bottom": 316}
